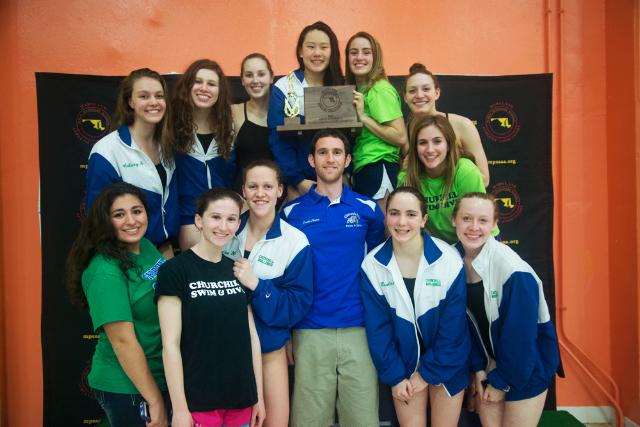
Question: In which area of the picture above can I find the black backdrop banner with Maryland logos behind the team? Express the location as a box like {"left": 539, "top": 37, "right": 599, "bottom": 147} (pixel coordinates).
{"left": 36, "top": 73, "right": 555, "bottom": 427}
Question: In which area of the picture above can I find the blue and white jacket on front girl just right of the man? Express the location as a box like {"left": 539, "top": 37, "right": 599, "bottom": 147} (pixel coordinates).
{"left": 360, "top": 232, "right": 470, "bottom": 396}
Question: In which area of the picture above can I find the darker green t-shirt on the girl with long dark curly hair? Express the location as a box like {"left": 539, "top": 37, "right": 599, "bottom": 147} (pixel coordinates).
{"left": 82, "top": 239, "right": 166, "bottom": 394}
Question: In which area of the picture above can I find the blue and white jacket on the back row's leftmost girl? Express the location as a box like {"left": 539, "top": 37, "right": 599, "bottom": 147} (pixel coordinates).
{"left": 86, "top": 125, "right": 179, "bottom": 245}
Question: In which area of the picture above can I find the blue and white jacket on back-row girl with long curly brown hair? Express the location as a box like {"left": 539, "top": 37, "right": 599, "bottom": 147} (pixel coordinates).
{"left": 176, "top": 133, "right": 236, "bottom": 225}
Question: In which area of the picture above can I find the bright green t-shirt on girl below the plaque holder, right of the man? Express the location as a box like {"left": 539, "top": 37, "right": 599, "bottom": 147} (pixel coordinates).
{"left": 398, "top": 158, "right": 500, "bottom": 243}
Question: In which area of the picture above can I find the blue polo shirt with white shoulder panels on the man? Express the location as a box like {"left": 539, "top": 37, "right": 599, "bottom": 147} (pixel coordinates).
{"left": 282, "top": 185, "right": 384, "bottom": 329}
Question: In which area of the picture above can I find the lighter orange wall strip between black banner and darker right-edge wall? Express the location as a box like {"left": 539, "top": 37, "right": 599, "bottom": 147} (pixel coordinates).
{"left": 553, "top": 0, "right": 612, "bottom": 406}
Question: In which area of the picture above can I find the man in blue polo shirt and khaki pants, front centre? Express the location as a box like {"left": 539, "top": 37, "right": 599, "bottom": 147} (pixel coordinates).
{"left": 283, "top": 129, "right": 384, "bottom": 427}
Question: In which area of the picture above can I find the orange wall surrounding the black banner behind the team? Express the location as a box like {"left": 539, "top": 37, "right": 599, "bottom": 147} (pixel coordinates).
{"left": 0, "top": 0, "right": 640, "bottom": 427}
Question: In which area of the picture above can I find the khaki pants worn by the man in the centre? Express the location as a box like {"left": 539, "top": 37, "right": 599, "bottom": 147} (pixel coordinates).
{"left": 291, "top": 327, "right": 379, "bottom": 427}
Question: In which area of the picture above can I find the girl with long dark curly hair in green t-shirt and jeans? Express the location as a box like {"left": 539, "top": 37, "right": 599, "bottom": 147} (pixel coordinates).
{"left": 67, "top": 182, "right": 167, "bottom": 427}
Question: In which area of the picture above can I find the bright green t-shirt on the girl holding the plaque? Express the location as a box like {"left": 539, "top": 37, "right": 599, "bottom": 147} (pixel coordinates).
{"left": 353, "top": 79, "right": 402, "bottom": 173}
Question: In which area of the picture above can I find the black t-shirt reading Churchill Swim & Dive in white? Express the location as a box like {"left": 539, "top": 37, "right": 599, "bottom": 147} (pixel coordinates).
{"left": 156, "top": 250, "right": 258, "bottom": 412}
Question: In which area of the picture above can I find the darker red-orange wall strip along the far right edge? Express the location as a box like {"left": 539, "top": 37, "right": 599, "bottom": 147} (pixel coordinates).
{"left": 605, "top": 0, "right": 640, "bottom": 420}
